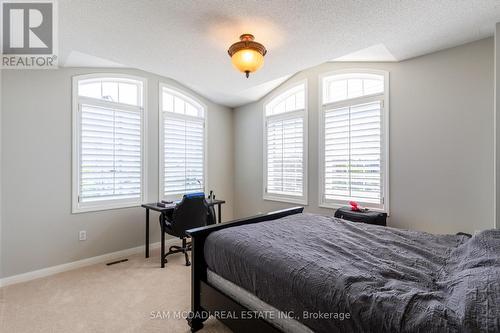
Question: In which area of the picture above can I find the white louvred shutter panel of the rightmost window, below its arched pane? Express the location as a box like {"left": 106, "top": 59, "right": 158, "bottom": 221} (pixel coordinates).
{"left": 325, "top": 101, "right": 382, "bottom": 204}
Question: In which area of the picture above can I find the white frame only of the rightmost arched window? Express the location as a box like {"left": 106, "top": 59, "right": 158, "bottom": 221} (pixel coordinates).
{"left": 318, "top": 68, "right": 390, "bottom": 214}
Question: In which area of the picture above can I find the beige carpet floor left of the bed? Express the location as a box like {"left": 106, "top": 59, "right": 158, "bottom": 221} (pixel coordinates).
{"left": 0, "top": 250, "right": 231, "bottom": 333}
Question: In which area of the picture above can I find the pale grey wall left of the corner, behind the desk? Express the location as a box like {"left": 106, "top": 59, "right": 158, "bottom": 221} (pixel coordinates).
{"left": 1, "top": 68, "right": 233, "bottom": 277}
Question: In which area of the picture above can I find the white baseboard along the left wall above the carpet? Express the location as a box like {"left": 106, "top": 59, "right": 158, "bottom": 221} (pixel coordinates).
{"left": 0, "top": 238, "right": 178, "bottom": 288}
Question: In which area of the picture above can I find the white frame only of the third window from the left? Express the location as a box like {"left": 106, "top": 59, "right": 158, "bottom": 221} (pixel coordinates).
{"left": 262, "top": 79, "right": 309, "bottom": 206}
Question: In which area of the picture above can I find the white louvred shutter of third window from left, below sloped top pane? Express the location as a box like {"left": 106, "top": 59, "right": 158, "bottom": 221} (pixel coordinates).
{"left": 267, "top": 116, "right": 304, "bottom": 196}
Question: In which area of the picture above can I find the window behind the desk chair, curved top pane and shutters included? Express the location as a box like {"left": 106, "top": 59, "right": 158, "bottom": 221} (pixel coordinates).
{"left": 160, "top": 85, "right": 206, "bottom": 199}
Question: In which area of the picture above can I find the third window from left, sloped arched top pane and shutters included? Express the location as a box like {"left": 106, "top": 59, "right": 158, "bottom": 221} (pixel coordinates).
{"left": 264, "top": 83, "right": 307, "bottom": 204}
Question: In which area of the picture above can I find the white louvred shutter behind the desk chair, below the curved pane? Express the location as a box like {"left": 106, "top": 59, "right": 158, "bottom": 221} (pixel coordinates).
{"left": 163, "top": 112, "right": 204, "bottom": 196}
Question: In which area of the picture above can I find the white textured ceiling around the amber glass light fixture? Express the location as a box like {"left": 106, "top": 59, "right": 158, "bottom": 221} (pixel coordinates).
{"left": 58, "top": 0, "right": 500, "bottom": 107}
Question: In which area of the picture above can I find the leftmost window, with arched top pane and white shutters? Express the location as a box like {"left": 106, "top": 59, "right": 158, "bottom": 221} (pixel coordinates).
{"left": 73, "top": 75, "right": 144, "bottom": 212}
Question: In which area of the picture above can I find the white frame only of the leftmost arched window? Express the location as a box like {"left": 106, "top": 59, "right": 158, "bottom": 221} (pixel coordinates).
{"left": 71, "top": 73, "right": 148, "bottom": 214}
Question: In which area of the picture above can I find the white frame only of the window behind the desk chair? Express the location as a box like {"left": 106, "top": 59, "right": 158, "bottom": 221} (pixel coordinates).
{"left": 158, "top": 81, "right": 208, "bottom": 201}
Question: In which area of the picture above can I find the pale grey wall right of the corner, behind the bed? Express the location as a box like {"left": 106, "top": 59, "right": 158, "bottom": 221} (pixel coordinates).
{"left": 233, "top": 38, "right": 494, "bottom": 233}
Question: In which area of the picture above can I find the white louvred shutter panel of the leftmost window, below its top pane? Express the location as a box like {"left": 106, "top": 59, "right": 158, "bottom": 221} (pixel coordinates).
{"left": 79, "top": 104, "right": 142, "bottom": 202}
